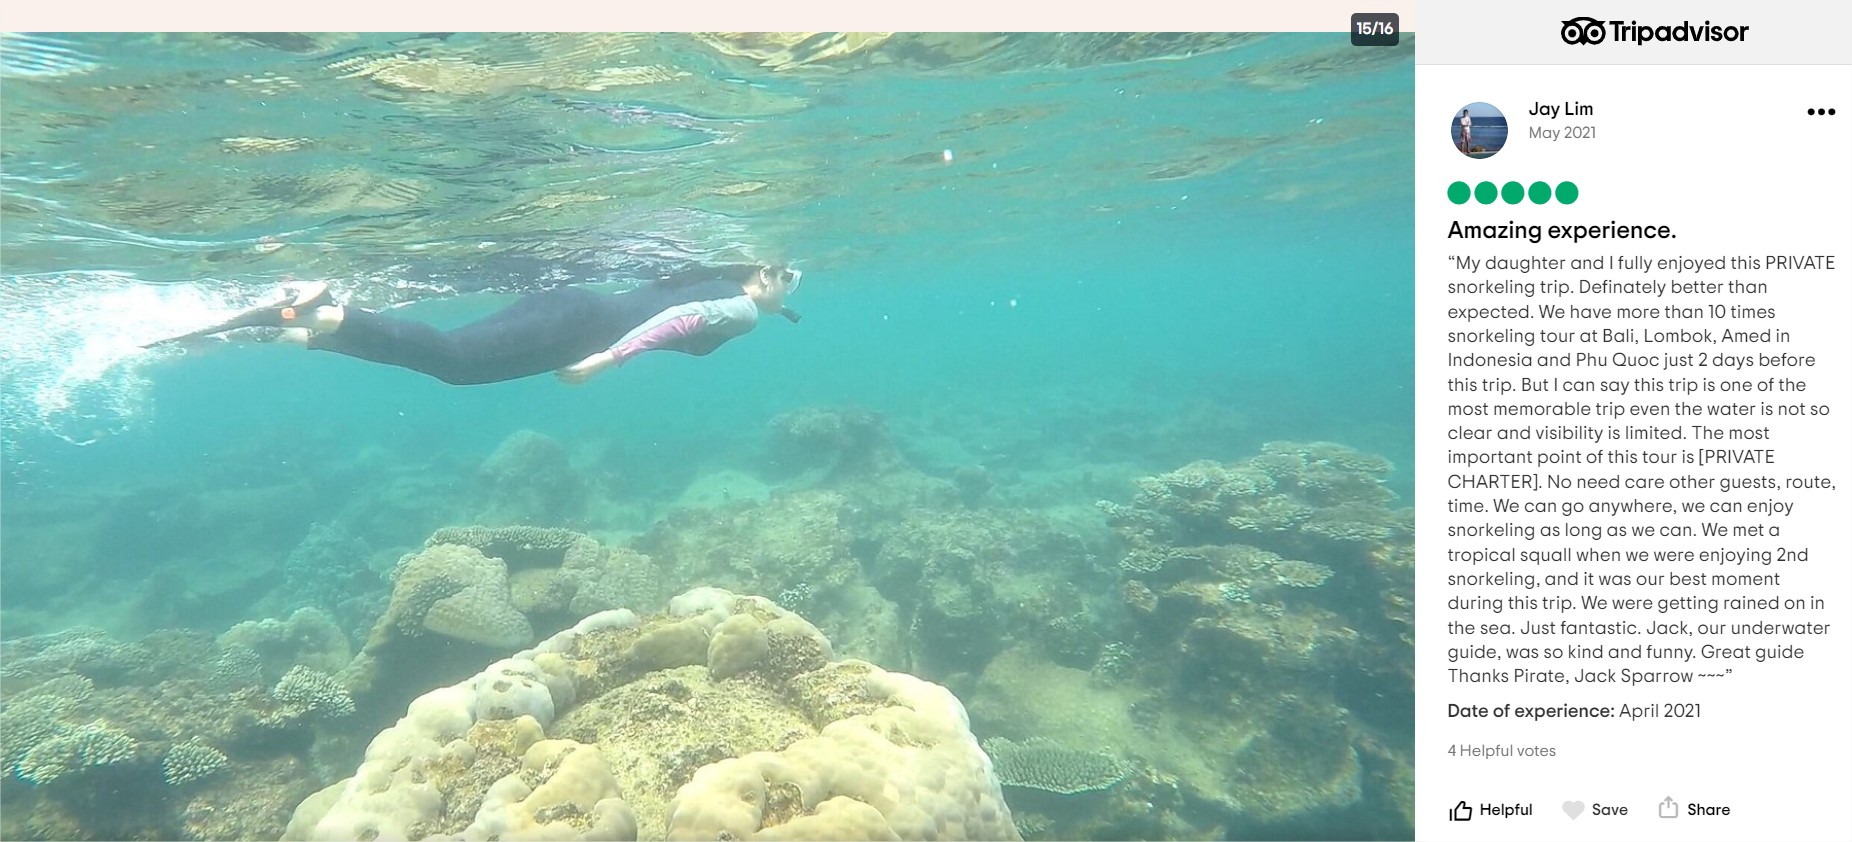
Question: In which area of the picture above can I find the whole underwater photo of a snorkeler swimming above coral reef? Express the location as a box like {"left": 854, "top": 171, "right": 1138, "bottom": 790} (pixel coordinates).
{"left": 0, "top": 31, "right": 1415, "bottom": 840}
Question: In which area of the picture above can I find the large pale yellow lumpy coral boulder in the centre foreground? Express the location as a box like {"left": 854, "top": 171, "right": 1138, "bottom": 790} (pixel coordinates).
{"left": 283, "top": 588, "right": 1019, "bottom": 838}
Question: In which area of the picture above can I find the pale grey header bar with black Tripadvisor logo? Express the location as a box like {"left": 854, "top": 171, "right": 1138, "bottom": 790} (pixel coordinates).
{"left": 1415, "top": 0, "right": 1852, "bottom": 65}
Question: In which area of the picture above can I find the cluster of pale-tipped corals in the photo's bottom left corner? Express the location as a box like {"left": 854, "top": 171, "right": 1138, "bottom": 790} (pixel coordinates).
{"left": 0, "top": 624, "right": 338, "bottom": 838}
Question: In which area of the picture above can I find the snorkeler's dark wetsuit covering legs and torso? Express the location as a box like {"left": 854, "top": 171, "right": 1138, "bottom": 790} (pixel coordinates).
{"left": 309, "top": 279, "right": 743, "bottom": 385}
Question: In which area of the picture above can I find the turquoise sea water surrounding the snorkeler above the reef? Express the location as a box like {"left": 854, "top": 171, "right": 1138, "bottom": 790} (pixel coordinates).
{"left": 0, "top": 35, "right": 1413, "bottom": 836}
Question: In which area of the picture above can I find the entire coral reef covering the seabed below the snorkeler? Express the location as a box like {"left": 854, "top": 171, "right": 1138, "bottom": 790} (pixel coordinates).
{"left": 0, "top": 409, "right": 1415, "bottom": 838}
